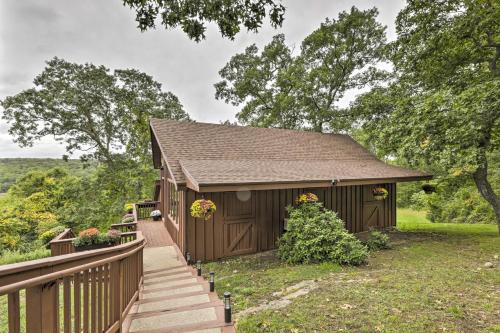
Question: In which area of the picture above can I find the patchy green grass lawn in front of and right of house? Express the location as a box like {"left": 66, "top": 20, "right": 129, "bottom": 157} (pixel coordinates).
{"left": 205, "top": 209, "right": 500, "bottom": 333}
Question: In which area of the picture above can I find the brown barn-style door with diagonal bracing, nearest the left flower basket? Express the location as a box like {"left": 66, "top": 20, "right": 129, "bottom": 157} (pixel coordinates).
{"left": 222, "top": 192, "right": 257, "bottom": 256}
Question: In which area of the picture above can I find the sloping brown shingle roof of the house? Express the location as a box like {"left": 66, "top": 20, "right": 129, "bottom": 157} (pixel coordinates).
{"left": 151, "top": 119, "right": 429, "bottom": 185}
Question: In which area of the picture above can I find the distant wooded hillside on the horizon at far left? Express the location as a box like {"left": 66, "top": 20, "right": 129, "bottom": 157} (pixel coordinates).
{"left": 0, "top": 158, "right": 95, "bottom": 193}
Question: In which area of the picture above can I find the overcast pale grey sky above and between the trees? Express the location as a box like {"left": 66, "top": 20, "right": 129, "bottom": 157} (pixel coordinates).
{"left": 0, "top": 0, "right": 404, "bottom": 158}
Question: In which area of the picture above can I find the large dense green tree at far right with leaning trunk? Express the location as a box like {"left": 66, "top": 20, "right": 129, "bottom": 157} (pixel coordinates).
{"left": 354, "top": 0, "right": 500, "bottom": 231}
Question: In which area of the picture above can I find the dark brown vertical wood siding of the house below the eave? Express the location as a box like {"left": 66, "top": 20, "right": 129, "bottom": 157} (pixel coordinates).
{"left": 182, "top": 183, "right": 396, "bottom": 261}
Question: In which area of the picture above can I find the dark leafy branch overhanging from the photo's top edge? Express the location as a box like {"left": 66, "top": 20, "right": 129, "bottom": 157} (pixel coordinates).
{"left": 123, "top": 0, "right": 285, "bottom": 42}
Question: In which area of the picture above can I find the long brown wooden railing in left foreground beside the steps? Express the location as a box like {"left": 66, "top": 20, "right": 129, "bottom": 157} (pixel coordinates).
{"left": 0, "top": 232, "right": 146, "bottom": 333}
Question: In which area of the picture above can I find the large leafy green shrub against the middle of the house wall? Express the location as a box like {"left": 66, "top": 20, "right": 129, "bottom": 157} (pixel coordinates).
{"left": 278, "top": 203, "right": 368, "bottom": 265}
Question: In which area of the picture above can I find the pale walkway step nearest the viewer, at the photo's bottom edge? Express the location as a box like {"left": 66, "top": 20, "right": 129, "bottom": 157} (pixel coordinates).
{"left": 129, "top": 307, "right": 217, "bottom": 332}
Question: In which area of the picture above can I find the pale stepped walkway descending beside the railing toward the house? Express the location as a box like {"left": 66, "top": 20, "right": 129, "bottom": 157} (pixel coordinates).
{"left": 123, "top": 220, "right": 235, "bottom": 333}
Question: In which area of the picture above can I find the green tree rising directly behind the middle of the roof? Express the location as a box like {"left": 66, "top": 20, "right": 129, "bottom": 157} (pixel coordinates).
{"left": 215, "top": 7, "right": 386, "bottom": 132}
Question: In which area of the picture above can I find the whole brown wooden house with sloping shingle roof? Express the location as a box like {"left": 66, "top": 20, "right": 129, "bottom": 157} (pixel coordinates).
{"left": 150, "top": 119, "right": 431, "bottom": 260}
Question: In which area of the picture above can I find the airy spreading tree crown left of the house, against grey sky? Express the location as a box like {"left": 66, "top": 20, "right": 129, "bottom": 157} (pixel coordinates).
{"left": 1, "top": 58, "right": 189, "bottom": 166}
